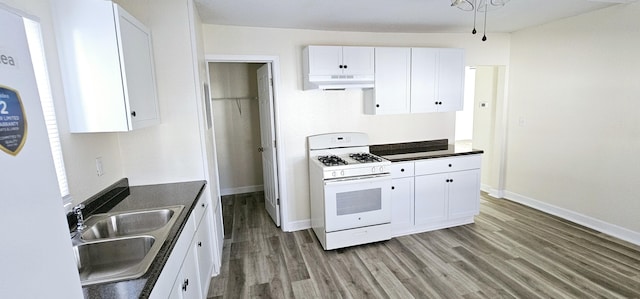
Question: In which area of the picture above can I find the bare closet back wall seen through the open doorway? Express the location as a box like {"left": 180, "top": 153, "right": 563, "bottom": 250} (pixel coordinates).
{"left": 209, "top": 62, "right": 263, "bottom": 194}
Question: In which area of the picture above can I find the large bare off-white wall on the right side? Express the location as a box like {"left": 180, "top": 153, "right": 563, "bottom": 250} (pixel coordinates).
{"left": 506, "top": 3, "right": 640, "bottom": 237}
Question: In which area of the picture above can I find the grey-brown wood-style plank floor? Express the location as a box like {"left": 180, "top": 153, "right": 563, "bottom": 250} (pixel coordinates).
{"left": 209, "top": 193, "right": 640, "bottom": 298}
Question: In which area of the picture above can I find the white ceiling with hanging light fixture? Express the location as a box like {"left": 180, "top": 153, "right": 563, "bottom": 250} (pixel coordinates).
{"left": 191, "top": 0, "right": 634, "bottom": 33}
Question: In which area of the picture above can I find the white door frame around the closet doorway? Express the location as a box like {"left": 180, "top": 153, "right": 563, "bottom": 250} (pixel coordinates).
{"left": 204, "top": 55, "right": 291, "bottom": 232}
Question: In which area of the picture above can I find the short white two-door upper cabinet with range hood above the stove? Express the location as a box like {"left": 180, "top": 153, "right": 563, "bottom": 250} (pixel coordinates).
{"left": 303, "top": 46, "right": 374, "bottom": 89}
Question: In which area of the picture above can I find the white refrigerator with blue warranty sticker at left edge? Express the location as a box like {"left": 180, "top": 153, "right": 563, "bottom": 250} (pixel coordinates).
{"left": 0, "top": 3, "right": 82, "bottom": 298}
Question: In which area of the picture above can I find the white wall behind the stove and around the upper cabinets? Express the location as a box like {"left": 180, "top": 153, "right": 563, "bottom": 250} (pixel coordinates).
{"left": 203, "top": 25, "right": 509, "bottom": 226}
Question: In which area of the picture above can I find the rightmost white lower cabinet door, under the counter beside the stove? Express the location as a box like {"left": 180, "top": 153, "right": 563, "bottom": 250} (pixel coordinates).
{"left": 448, "top": 169, "right": 480, "bottom": 219}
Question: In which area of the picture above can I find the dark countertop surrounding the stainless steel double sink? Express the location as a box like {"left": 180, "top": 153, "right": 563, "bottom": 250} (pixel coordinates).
{"left": 82, "top": 181, "right": 206, "bottom": 298}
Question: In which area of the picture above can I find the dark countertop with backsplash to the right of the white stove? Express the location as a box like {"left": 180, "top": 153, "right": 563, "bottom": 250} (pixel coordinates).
{"left": 369, "top": 139, "right": 484, "bottom": 162}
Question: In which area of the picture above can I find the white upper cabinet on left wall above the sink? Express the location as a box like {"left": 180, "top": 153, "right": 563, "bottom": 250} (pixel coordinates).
{"left": 52, "top": 0, "right": 160, "bottom": 133}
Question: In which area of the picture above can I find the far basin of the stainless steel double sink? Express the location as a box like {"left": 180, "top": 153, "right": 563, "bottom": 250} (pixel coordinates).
{"left": 82, "top": 208, "right": 175, "bottom": 240}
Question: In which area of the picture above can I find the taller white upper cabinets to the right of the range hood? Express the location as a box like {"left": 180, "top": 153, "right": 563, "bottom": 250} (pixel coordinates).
{"left": 364, "top": 47, "right": 464, "bottom": 114}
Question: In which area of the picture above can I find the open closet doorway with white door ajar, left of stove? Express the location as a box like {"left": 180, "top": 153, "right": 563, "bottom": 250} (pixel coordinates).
{"left": 206, "top": 56, "right": 287, "bottom": 231}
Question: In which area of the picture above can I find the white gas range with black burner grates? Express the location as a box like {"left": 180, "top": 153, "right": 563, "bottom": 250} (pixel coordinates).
{"left": 307, "top": 132, "right": 391, "bottom": 250}
